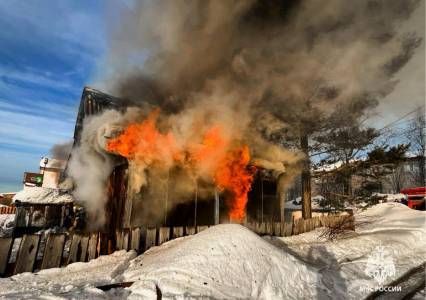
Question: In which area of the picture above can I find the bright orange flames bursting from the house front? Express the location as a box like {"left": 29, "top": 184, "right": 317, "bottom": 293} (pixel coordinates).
{"left": 106, "top": 110, "right": 254, "bottom": 222}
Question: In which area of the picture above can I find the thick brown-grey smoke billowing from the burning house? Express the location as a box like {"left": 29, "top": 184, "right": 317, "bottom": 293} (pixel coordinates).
{"left": 69, "top": 0, "right": 420, "bottom": 226}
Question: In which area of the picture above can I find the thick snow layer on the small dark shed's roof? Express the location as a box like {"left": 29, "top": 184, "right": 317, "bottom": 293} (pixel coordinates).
{"left": 13, "top": 186, "right": 74, "bottom": 204}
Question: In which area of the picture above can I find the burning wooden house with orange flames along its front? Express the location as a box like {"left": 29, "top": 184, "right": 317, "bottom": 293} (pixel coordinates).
{"left": 67, "top": 87, "right": 283, "bottom": 239}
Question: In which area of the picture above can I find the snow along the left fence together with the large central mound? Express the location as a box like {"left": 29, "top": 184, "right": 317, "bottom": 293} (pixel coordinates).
{"left": 0, "top": 225, "right": 322, "bottom": 299}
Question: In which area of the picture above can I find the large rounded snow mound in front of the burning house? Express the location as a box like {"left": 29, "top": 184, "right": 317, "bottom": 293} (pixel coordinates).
{"left": 121, "top": 224, "right": 319, "bottom": 299}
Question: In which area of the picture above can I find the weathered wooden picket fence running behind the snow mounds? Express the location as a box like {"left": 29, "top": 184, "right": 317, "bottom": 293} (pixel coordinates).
{"left": 0, "top": 215, "right": 353, "bottom": 276}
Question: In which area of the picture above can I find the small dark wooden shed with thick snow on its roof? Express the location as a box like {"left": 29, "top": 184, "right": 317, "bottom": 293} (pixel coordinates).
{"left": 13, "top": 187, "right": 74, "bottom": 234}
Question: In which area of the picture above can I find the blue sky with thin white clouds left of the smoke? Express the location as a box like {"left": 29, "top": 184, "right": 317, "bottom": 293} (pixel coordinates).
{"left": 0, "top": 0, "right": 116, "bottom": 192}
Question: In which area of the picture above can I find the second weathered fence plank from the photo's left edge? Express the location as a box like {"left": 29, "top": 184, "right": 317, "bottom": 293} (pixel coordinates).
{"left": 13, "top": 234, "right": 40, "bottom": 274}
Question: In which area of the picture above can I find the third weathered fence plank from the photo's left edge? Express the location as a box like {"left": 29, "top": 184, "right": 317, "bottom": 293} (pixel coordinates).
{"left": 41, "top": 233, "right": 65, "bottom": 269}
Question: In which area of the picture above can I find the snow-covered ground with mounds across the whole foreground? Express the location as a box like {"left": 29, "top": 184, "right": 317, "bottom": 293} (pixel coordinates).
{"left": 0, "top": 203, "right": 426, "bottom": 299}
